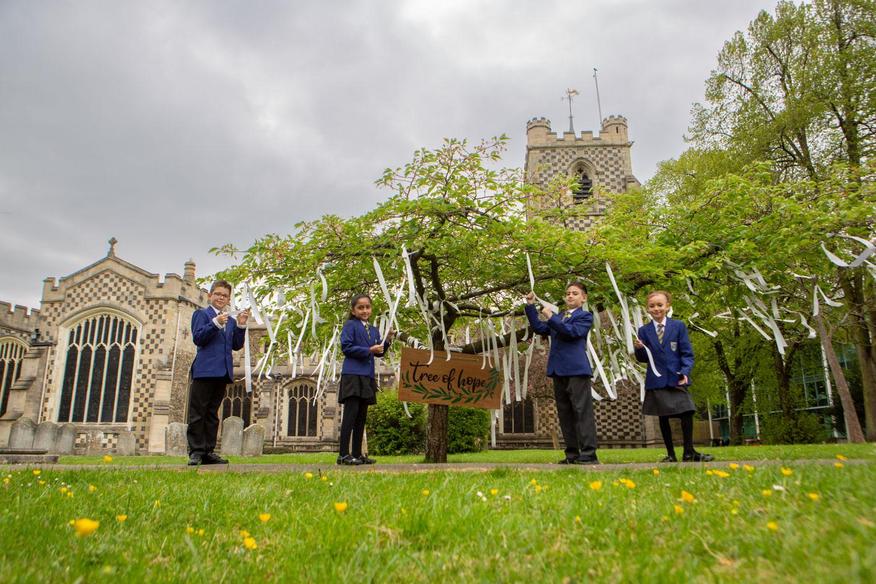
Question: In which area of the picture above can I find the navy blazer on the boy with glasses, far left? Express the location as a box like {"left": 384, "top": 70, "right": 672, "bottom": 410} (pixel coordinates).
{"left": 192, "top": 306, "right": 246, "bottom": 382}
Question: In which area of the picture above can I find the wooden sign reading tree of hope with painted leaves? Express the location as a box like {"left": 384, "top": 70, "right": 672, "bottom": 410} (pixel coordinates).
{"left": 398, "top": 347, "right": 502, "bottom": 410}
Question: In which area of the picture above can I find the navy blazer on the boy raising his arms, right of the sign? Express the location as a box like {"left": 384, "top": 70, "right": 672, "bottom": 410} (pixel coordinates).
{"left": 526, "top": 304, "right": 593, "bottom": 377}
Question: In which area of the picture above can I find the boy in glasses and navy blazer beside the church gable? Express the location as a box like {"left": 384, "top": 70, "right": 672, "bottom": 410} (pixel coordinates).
{"left": 186, "top": 280, "right": 249, "bottom": 466}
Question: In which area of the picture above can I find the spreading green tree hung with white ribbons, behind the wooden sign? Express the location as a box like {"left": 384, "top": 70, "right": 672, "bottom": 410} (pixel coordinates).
{"left": 219, "top": 137, "right": 599, "bottom": 462}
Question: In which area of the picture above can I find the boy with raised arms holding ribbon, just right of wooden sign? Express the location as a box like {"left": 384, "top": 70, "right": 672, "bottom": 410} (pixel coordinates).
{"left": 526, "top": 282, "right": 599, "bottom": 464}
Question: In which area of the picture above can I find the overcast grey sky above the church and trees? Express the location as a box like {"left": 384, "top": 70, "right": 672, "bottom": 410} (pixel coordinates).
{"left": 0, "top": 0, "right": 775, "bottom": 307}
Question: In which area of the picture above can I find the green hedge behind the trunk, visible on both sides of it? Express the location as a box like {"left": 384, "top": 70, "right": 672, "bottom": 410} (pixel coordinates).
{"left": 368, "top": 390, "right": 490, "bottom": 455}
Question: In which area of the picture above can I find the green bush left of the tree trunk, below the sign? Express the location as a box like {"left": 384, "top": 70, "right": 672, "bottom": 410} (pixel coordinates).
{"left": 368, "top": 390, "right": 426, "bottom": 455}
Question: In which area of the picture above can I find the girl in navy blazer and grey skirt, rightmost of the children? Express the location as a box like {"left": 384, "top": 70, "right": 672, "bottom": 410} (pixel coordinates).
{"left": 633, "top": 290, "right": 714, "bottom": 462}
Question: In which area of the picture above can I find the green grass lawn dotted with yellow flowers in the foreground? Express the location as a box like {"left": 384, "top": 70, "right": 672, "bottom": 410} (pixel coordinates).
{"left": 0, "top": 445, "right": 876, "bottom": 582}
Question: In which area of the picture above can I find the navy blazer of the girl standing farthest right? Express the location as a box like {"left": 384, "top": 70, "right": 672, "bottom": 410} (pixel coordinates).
{"left": 636, "top": 317, "right": 693, "bottom": 389}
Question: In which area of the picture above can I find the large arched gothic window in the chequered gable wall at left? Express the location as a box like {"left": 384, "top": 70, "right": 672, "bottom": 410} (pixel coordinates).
{"left": 58, "top": 313, "right": 140, "bottom": 424}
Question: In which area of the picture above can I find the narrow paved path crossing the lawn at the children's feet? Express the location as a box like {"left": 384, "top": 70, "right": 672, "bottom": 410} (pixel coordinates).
{"left": 0, "top": 459, "right": 876, "bottom": 474}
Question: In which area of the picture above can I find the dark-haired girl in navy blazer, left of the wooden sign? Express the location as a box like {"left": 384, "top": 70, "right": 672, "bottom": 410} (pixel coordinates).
{"left": 338, "top": 294, "right": 392, "bottom": 465}
